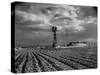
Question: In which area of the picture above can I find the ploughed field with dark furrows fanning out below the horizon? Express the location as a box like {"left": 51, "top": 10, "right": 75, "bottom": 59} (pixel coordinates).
{"left": 15, "top": 48, "right": 97, "bottom": 73}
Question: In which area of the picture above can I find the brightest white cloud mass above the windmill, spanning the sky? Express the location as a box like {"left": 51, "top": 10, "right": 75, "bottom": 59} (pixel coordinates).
{"left": 16, "top": 5, "right": 97, "bottom": 32}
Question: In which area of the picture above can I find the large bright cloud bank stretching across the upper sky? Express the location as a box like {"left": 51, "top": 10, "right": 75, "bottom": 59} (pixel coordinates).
{"left": 16, "top": 5, "right": 96, "bottom": 32}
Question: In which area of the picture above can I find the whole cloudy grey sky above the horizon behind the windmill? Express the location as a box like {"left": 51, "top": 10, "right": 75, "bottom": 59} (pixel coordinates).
{"left": 12, "top": 3, "right": 97, "bottom": 46}
